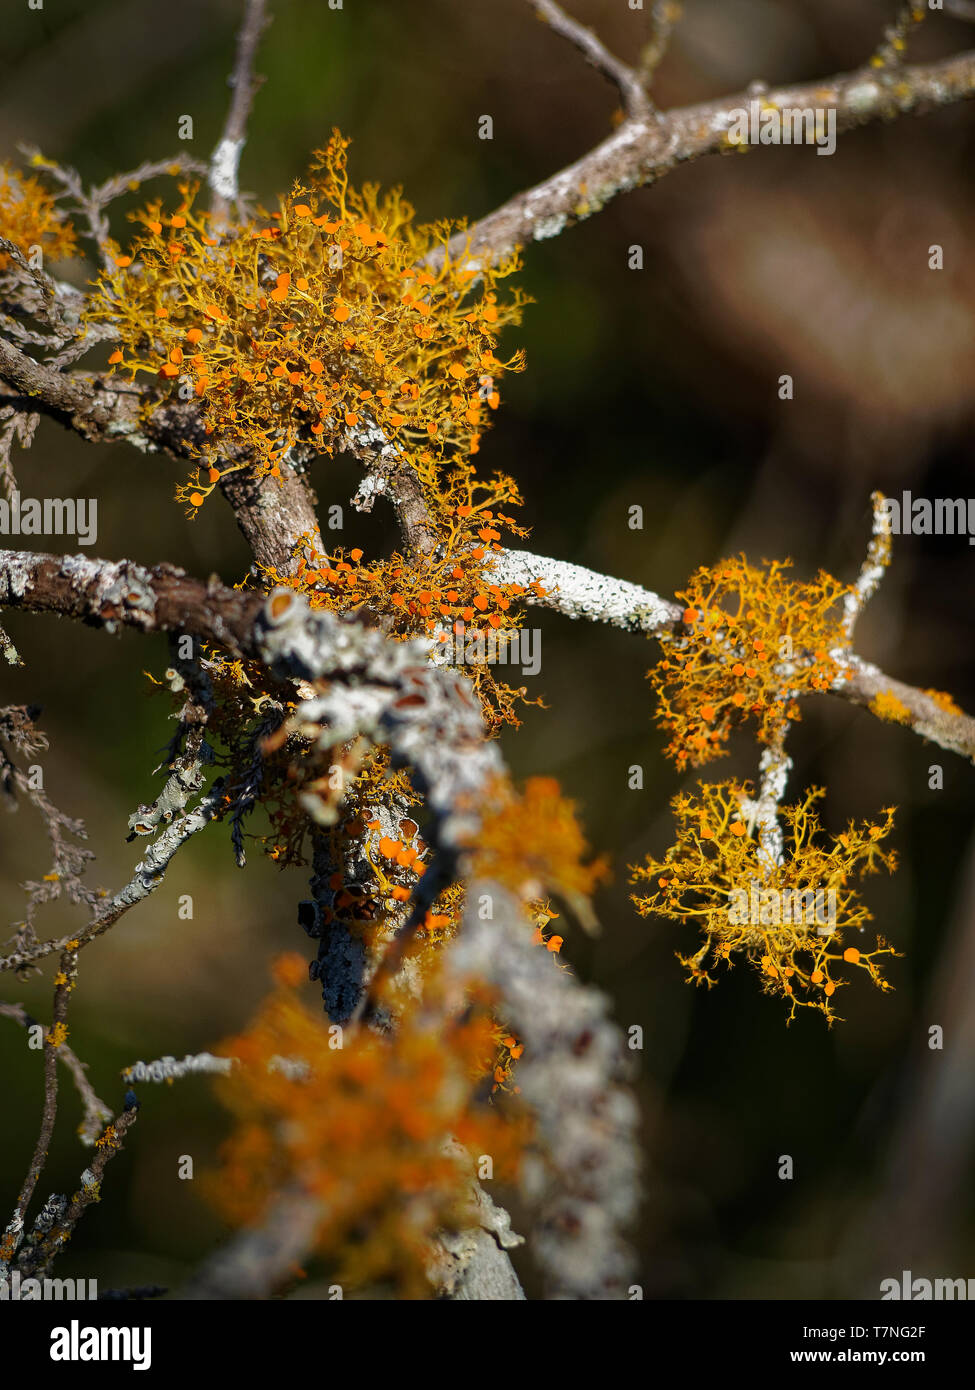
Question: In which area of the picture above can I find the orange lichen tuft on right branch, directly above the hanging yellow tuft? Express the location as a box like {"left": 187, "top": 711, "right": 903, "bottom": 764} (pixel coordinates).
{"left": 650, "top": 556, "right": 850, "bottom": 769}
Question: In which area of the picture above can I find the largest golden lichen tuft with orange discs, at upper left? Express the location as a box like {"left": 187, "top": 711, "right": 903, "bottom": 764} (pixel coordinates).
{"left": 89, "top": 133, "right": 526, "bottom": 507}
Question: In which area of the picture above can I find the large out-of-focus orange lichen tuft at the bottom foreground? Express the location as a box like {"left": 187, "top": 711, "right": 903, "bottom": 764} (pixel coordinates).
{"left": 201, "top": 967, "right": 527, "bottom": 1298}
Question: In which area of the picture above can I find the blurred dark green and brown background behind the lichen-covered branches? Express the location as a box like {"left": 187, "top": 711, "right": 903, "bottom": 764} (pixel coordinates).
{"left": 0, "top": 0, "right": 975, "bottom": 1298}
